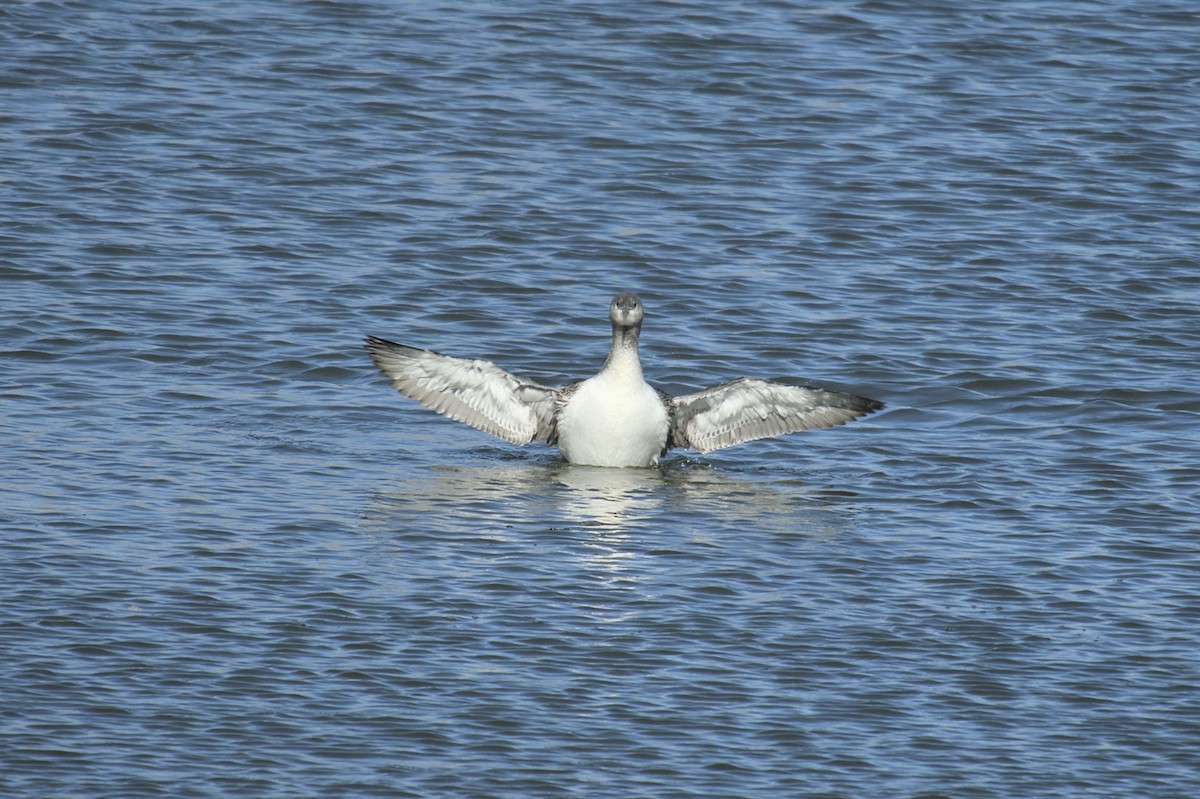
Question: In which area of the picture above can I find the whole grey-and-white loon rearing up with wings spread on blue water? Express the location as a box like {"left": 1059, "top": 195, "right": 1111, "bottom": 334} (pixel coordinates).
{"left": 365, "top": 292, "right": 883, "bottom": 467}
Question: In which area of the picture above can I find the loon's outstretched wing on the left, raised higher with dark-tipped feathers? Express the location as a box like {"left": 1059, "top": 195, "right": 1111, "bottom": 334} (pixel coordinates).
{"left": 365, "top": 336, "right": 554, "bottom": 444}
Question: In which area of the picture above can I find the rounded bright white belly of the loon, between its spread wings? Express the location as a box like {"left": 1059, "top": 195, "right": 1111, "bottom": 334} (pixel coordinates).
{"left": 558, "top": 374, "right": 670, "bottom": 467}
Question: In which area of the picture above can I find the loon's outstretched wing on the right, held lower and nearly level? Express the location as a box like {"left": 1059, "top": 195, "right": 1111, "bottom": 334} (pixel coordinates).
{"left": 670, "top": 378, "right": 883, "bottom": 452}
